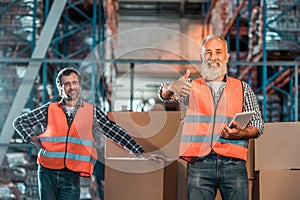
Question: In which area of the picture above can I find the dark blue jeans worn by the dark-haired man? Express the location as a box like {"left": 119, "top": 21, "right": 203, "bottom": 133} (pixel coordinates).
{"left": 38, "top": 165, "right": 80, "bottom": 200}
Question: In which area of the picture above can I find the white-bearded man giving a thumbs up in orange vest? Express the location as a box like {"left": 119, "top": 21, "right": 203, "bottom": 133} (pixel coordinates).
{"left": 159, "top": 35, "right": 264, "bottom": 200}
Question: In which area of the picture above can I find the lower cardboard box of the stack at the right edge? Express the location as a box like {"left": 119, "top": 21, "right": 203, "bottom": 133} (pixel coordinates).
{"left": 259, "top": 170, "right": 300, "bottom": 200}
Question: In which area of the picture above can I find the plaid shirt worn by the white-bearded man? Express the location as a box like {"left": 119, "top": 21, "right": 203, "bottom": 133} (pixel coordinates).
{"left": 158, "top": 75, "right": 264, "bottom": 137}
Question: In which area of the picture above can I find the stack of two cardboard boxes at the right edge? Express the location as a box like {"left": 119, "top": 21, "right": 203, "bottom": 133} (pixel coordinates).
{"left": 255, "top": 122, "right": 300, "bottom": 200}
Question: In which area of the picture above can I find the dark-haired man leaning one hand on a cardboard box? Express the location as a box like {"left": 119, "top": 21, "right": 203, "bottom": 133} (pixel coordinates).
{"left": 13, "top": 68, "right": 164, "bottom": 200}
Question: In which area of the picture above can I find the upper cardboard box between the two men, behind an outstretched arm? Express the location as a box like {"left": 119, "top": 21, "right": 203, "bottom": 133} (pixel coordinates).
{"left": 105, "top": 111, "right": 183, "bottom": 160}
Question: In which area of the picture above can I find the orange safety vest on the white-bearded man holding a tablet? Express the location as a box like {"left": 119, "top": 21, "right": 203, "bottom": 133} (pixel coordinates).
{"left": 179, "top": 77, "right": 248, "bottom": 160}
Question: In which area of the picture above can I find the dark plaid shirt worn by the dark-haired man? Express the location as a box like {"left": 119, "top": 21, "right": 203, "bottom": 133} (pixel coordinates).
{"left": 13, "top": 100, "right": 144, "bottom": 155}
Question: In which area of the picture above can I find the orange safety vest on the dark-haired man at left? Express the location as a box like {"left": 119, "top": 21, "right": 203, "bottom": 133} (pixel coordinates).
{"left": 37, "top": 102, "right": 97, "bottom": 177}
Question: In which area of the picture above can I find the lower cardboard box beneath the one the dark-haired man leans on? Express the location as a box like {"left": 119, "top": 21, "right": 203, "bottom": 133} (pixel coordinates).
{"left": 104, "top": 160, "right": 177, "bottom": 200}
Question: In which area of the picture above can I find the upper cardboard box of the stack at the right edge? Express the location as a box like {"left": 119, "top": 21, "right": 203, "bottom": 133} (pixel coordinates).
{"left": 255, "top": 122, "right": 300, "bottom": 170}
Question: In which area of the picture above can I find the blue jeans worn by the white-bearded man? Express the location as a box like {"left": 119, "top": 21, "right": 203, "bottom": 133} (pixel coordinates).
{"left": 188, "top": 153, "right": 248, "bottom": 200}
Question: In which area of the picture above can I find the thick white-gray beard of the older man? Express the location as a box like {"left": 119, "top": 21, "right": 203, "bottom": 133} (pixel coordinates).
{"left": 201, "top": 62, "right": 227, "bottom": 81}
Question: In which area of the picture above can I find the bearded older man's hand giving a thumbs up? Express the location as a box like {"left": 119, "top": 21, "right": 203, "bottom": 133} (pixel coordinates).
{"left": 169, "top": 70, "right": 192, "bottom": 97}
